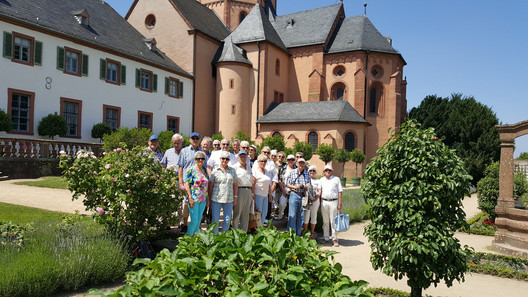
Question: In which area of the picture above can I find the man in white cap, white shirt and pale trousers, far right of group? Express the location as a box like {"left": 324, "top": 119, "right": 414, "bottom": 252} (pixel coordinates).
{"left": 318, "top": 165, "right": 343, "bottom": 247}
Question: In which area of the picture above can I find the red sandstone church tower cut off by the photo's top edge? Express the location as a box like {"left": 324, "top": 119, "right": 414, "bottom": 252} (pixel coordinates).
{"left": 196, "top": 0, "right": 277, "bottom": 31}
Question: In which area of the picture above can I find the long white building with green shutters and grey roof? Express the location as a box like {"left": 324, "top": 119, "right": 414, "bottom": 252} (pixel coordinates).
{"left": 0, "top": 0, "right": 193, "bottom": 142}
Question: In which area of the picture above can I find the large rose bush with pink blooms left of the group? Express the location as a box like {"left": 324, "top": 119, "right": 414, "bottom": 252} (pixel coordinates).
{"left": 60, "top": 148, "right": 183, "bottom": 239}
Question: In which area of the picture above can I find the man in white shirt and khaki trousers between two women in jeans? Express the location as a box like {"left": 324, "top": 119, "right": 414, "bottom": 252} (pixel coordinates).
{"left": 233, "top": 150, "right": 255, "bottom": 232}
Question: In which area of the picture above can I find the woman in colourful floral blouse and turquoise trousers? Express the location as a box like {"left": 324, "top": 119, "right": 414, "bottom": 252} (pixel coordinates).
{"left": 185, "top": 151, "right": 208, "bottom": 235}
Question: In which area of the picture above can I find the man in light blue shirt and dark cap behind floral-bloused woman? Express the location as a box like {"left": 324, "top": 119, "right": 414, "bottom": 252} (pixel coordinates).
{"left": 178, "top": 132, "right": 207, "bottom": 233}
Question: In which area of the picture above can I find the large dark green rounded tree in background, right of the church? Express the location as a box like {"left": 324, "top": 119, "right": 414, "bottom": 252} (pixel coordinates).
{"left": 409, "top": 94, "right": 500, "bottom": 184}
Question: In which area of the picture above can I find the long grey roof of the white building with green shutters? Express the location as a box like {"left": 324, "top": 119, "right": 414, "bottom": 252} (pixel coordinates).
{"left": 0, "top": 0, "right": 192, "bottom": 76}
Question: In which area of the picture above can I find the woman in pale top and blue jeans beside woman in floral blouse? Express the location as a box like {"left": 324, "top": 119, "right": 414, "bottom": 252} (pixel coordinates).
{"left": 207, "top": 151, "right": 238, "bottom": 234}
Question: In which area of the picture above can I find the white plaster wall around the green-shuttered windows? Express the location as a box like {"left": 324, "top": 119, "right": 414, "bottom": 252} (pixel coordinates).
{"left": 0, "top": 22, "right": 193, "bottom": 142}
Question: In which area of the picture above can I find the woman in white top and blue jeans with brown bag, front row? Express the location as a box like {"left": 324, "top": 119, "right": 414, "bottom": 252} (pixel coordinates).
{"left": 253, "top": 155, "right": 272, "bottom": 224}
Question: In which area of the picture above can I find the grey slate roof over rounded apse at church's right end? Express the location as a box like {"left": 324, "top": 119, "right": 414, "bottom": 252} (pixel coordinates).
{"left": 328, "top": 15, "right": 398, "bottom": 54}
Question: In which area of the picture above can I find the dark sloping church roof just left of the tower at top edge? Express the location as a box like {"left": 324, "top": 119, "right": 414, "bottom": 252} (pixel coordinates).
{"left": 171, "top": 0, "right": 227, "bottom": 41}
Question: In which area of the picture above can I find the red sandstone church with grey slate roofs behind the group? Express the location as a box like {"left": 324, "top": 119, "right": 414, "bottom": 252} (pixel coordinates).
{"left": 126, "top": 0, "right": 407, "bottom": 175}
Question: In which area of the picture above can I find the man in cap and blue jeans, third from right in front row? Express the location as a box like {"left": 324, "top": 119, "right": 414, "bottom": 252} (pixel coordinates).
{"left": 285, "top": 158, "right": 311, "bottom": 236}
